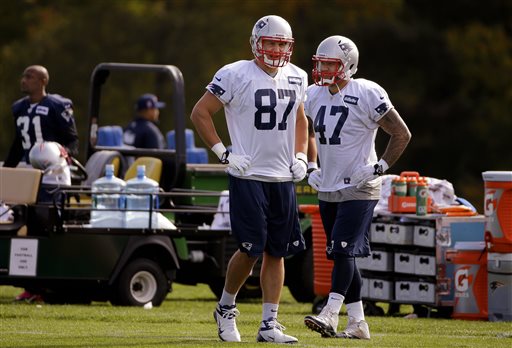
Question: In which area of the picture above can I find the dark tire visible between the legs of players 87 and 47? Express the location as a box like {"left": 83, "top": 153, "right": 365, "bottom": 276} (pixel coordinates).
{"left": 285, "top": 247, "right": 316, "bottom": 303}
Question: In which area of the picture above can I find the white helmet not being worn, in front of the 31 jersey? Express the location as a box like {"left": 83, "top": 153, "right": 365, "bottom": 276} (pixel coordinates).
{"left": 28, "top": 141, "right": 71, "bottom": 185}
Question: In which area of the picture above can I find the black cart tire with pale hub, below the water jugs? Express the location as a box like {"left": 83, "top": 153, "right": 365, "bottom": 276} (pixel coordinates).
{"left": 110, "top": 258, "right": 170, "bottom": 306}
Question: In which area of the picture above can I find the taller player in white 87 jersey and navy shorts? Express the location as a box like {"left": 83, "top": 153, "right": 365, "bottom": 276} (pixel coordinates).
{"left": 191, "top": 15, "right": 308, "bottom": 343}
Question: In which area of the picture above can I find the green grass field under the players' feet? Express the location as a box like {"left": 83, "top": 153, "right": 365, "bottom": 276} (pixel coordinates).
{"left": 0, "top": 284, "right": 512, "bottom": 348}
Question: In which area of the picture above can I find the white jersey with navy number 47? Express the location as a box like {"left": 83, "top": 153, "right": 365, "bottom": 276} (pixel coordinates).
{"left": 304, "top": 79, "right": 393, "bottom": 192}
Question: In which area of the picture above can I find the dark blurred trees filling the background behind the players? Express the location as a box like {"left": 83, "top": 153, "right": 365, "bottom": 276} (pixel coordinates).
{"left": 0, "top": 0, "right": 512, "bottom": 210}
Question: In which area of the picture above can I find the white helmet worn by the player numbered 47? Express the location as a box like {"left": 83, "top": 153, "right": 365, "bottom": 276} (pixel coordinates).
{"left": 312, "top": 35, "right": 359, "bottom": 86}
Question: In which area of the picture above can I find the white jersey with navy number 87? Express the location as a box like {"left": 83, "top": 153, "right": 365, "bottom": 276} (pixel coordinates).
{"left": 206, "top": 60, "right": 308, "bottom": 181}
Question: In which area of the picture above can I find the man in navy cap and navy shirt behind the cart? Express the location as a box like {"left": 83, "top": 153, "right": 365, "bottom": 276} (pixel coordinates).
{"left": 123, "top": 93, "right": 165, "bottom": 149}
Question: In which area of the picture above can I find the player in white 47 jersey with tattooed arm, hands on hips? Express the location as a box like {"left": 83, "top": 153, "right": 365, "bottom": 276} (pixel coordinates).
{"left": 304, "top": 35, "right": 411, "bottom": 339}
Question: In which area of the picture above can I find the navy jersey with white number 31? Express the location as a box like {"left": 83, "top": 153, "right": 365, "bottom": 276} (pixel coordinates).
{"left": 4, "top": 94, "right": 78, "bottom": 166}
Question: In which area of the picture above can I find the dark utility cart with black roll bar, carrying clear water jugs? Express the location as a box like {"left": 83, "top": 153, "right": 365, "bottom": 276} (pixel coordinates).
{"left": 0, "top": 63, "right": 316, "bottom": 306}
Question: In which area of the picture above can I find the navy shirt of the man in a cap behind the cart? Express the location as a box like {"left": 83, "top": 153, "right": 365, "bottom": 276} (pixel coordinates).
{"left": 123, "top": 117, "right": 165, "bottom": 149}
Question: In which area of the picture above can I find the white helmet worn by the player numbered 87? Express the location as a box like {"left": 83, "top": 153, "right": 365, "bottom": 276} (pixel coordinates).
{"left": 249, "top": 15, "right": 294, "bottom": 68}
